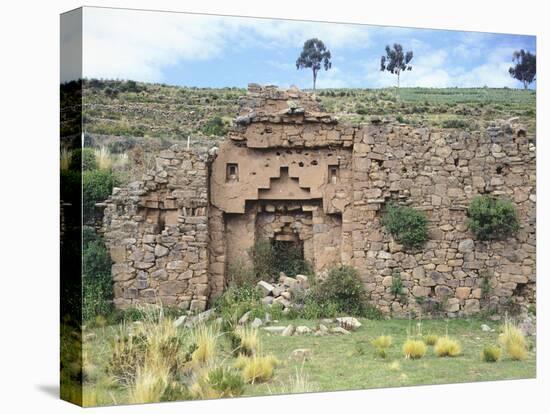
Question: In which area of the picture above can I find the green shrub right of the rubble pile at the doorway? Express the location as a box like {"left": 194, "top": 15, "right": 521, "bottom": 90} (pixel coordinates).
{"left": 309, "top": 266, "right": 366, "bottom": 317}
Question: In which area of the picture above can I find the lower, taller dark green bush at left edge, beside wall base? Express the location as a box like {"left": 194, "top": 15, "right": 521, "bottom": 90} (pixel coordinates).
{"left": 82, "top": 233, "right": 113, "bottom": 321}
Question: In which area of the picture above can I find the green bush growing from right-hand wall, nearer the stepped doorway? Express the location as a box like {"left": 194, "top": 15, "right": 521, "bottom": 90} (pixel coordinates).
{"left": 382, "top": 203, "right": 428, "bottom": 249}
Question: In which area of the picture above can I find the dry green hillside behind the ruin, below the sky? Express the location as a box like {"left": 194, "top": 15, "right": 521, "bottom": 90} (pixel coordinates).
{"left": 83, "top": 80, "right": 536, "bottom": 141}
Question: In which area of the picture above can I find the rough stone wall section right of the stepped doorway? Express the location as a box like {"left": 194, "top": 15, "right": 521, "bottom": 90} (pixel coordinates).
{"left": 351, "top": 122, "right": 536, "bottom": 316}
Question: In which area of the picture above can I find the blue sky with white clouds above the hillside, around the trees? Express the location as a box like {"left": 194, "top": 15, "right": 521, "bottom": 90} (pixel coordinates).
{"left": 73, "top": 8, "right": 536, "bottom": 88}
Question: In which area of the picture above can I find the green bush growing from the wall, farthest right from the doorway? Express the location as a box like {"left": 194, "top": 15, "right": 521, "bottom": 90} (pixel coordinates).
{"left": 468, "top": 195, "right": 519, "bottom": 240}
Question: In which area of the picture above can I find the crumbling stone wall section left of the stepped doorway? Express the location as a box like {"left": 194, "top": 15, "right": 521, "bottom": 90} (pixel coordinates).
{"left": 104, "top": 146, "right": 212, "bottom": 310}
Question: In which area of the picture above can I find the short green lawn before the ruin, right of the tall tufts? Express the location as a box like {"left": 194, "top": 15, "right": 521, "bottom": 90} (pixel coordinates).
{"left": 253, "top": 319, "right": 536, "bottom": 395}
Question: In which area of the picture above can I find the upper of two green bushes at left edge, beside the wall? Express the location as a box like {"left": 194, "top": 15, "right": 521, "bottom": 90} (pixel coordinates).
{"left": 82, "top": 170, "right": 116, "bottom": 223}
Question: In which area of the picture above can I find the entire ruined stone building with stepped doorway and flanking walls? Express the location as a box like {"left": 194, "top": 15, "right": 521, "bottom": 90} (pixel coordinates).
{"left": 104, "top": 84, "right": 536, "bottom": 316}
